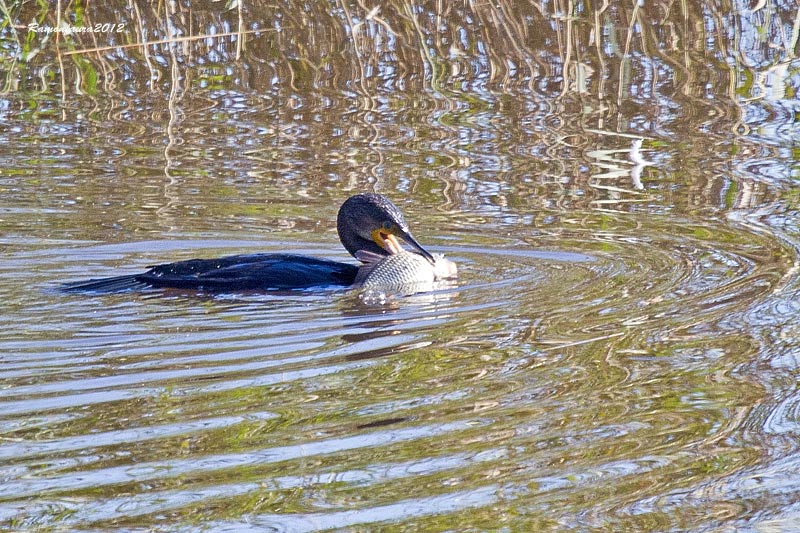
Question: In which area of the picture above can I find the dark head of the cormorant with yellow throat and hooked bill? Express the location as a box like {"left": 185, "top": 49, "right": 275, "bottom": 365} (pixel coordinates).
{"left": 336, "top": 193, "right": 435, "bottom": 264}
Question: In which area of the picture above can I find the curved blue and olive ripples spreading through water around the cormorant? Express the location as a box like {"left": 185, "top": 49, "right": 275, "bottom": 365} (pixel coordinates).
{"left": 0, "top": 216, "right": 795, "bottom": 531}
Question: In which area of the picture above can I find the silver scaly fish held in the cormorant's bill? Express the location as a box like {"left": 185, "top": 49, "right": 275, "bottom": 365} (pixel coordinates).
{"left": 355, "top": 250, "right": 458, "bottom": 292}
